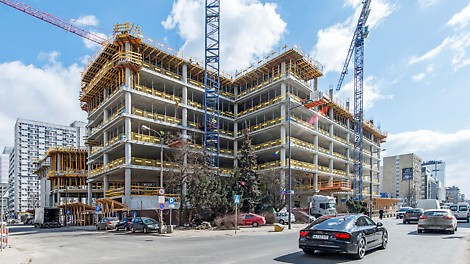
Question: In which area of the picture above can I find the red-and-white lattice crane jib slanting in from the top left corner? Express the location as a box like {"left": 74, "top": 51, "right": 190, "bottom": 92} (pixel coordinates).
{"left": 0, "top": 0, "right": 106, "bottom": 45}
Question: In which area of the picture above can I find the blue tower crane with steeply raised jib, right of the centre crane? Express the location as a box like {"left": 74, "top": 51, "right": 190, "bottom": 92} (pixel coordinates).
{"left": 336, "top": 0, "right": 372, "bottom": 200}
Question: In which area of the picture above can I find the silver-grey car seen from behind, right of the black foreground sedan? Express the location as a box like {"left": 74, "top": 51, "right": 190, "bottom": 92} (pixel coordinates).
{"left": 418, "top": 209, "right": 457, "bottom": 234}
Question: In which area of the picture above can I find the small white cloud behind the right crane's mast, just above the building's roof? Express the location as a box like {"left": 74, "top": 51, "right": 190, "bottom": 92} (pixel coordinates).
{"left": 336, "top": 76, "right": 393, "bottom": 111}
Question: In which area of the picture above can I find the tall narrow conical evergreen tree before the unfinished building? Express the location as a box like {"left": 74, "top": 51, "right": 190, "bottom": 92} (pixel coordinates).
{"left": 234, "top": 129, "right": 261, "bottom": 213}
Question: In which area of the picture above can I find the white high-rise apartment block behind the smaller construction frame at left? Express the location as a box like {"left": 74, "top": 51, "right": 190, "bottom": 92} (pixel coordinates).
{"left": 8, "top": 119, "right": 86, "bottom": 213}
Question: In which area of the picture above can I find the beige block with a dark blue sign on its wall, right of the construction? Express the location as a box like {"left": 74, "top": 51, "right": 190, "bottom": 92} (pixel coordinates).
{"left": 382, "top": 153, "right": 422, "bottom": 203}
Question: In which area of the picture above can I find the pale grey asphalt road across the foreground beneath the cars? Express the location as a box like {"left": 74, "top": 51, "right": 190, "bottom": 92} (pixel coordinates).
{"left": 0, "top": 219, "right": 470, "bottom": 264}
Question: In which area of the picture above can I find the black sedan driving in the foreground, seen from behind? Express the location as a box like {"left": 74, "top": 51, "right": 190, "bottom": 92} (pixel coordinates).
{"left": 299, "top": 215, "right": 388, "bottom": 259}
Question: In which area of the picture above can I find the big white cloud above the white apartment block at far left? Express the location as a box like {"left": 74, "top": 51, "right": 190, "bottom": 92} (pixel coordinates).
{"left": 0, "top": 52, "right": 86, "bottom": 146}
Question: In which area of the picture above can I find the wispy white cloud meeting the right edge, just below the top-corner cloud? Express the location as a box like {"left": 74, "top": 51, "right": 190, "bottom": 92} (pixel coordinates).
{"left": 408, "top": 32, "right": 470, "bottom": 71}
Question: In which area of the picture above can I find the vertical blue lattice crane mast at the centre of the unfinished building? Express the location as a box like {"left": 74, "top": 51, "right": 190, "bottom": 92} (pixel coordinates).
{"left": 204, "top": 0, "right": 220, "bottom": 169}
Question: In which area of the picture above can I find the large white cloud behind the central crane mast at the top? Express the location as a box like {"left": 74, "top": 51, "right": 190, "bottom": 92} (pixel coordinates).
{"left": 162, "top": 0, "right": 287, "bottom": 73}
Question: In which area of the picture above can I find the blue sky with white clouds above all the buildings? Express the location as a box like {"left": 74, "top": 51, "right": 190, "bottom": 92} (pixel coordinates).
{"left": 0, "top": 0, "right": 470, "bottom": 197}
